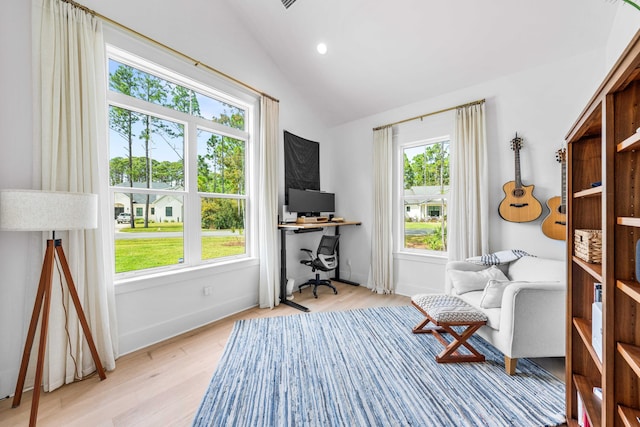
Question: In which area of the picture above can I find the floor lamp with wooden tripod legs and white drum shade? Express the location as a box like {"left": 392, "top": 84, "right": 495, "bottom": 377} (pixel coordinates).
{"left": 0, "top": 190, "right": 107, "bottom": 426}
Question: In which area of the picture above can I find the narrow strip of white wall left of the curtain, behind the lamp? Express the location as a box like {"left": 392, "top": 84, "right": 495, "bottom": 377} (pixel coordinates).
{"left": 0, "top": 0, "right": 35, "bottom": 398}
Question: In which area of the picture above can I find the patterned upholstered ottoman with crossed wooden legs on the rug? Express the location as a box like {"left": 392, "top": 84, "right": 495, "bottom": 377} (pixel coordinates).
{"left": 411, "top": 294, "right": 487, "bottom": 363}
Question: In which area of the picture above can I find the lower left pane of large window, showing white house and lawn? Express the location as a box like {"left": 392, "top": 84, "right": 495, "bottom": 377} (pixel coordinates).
{"left": 115, "top": 193, "right": 184, "bottom": 273}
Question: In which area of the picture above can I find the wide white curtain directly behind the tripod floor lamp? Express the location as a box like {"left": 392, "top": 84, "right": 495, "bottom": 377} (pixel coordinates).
{"left": 34, "top": 0, "right": 117, "bottom": 391}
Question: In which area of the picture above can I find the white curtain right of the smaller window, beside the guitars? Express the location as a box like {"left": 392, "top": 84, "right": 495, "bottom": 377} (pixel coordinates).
{"left": 448, "top": 102, "right": 489, "bottom": 260}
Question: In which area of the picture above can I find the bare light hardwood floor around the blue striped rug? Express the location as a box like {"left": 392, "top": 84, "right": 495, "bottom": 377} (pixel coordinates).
{"left": 0, "top": 283, "right": 410, "bottom": 427}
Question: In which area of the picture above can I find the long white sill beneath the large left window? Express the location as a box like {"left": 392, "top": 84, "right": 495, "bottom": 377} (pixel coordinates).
{"left": 114, "top": 258, "right": 260, "bottom": 295}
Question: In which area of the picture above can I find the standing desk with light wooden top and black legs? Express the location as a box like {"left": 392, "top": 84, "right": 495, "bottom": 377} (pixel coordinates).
{"left": 278, "top": 221, "right": 362, "bottom": 311}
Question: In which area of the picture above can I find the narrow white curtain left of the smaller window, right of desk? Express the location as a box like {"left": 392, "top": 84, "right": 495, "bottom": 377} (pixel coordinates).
{"left": 367, "top": 126, "right": 395, "bottom": 294}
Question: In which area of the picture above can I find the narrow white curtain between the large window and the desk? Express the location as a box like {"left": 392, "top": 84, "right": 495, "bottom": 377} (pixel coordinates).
{"left": 258, "top": 96, "right": 280, "bottom": 308}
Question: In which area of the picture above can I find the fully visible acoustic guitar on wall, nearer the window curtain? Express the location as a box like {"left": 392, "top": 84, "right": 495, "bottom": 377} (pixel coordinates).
{"left": 498, "top": 133, "right": 542, "bottom": 222}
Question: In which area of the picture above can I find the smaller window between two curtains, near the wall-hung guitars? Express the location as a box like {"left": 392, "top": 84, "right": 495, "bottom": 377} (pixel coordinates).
{"left": 399, "top": 136, "right": 449, "bottom": 252}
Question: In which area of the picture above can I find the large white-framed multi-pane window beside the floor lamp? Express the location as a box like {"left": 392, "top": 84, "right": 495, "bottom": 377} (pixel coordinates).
{"left": 108, "top": 48, "right": 253, "bottom": 274}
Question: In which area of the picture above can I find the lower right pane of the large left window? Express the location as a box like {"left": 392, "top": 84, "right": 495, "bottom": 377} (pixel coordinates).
{"left": 201, "top": 197, "right": 246, "bottom": 260}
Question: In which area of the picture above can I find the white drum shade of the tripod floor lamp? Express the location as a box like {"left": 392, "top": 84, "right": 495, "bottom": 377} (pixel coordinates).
{"left": 0, "top": 190, "right": 98, "bottom": 231}
